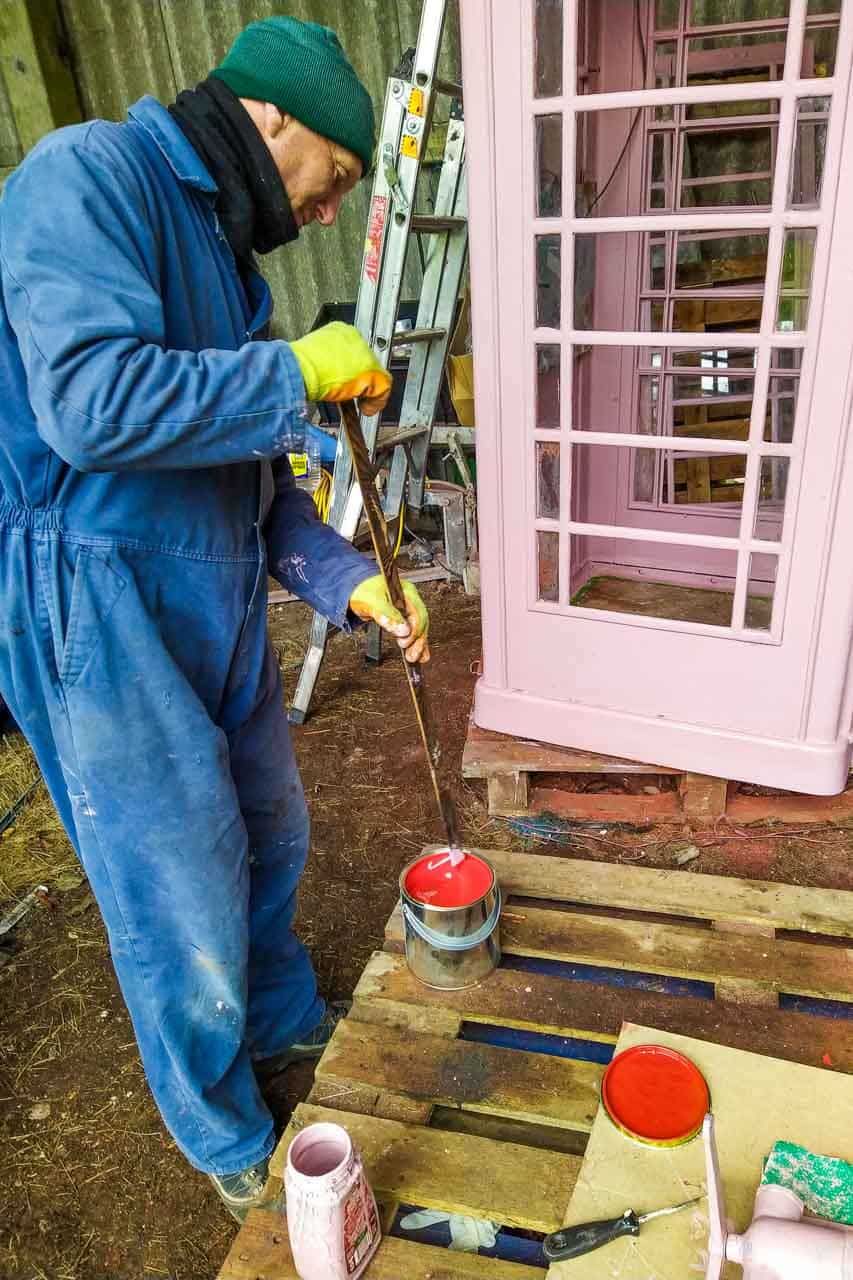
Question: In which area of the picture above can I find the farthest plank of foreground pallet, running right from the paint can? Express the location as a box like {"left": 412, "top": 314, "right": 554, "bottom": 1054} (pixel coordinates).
{"left": 448, "top": 849, "right": 853, "bottom": 937}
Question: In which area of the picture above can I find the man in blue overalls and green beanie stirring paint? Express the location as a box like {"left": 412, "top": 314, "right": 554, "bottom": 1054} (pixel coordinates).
{"left": 0, "top": 18, "right": 428, "bottom": 1217}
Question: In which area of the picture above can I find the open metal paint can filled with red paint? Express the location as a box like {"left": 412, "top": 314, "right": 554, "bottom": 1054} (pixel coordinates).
{"left": 400, "top": 850, "right": 501, "bottom": 991}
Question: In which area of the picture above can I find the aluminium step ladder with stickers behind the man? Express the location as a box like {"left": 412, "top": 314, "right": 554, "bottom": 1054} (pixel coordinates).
{"left": 289, "top": 0, "right": 467, "bottom": 724}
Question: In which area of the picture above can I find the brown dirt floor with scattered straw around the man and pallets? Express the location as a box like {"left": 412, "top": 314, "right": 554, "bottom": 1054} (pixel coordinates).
{"left": 0, "top": 585, "right": 853, "bottom": 1280}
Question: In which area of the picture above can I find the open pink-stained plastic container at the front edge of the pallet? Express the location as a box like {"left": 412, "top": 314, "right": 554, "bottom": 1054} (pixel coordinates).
{"left": 284, "top": 1124, "right": 382, "bottom": 1280}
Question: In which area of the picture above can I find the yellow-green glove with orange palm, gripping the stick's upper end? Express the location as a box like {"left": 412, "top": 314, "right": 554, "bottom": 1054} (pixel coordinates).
{"left": 291, "top": 320, "right": 392, "bottom": 417}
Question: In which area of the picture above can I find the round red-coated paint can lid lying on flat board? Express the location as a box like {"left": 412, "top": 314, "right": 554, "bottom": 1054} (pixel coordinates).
{"left": 601, "top": 1044, "right": 711, "bottom": 1147}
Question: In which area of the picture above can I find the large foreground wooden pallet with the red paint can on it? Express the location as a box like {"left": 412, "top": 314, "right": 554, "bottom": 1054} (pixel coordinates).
{"left": 220, "top": 852, "right": 853, "bottom": 1280}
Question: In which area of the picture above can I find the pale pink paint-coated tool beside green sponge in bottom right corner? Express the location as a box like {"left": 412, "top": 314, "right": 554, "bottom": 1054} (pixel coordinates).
{"left": 702, "top": 1115, "right": 853, "bottom": 1280}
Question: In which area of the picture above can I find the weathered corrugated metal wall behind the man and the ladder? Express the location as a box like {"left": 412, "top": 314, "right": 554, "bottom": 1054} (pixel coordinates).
{"left": 51, "top": 0, "right": 460, "bottom": 338}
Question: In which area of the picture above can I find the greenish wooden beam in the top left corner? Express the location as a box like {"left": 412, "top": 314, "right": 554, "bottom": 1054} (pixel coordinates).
{"left": 0, "top": 0, "right": 83, "bottom": 154}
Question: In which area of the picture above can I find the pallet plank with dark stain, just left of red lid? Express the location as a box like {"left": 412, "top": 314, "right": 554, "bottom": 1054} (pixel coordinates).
{"left": 316, "top": 1018, "right": 603, "bottom": 1133}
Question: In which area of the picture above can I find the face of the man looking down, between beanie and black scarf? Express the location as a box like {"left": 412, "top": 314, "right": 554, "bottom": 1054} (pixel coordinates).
{"left": 261, "top": 104, "right": 362, "bottom": 227}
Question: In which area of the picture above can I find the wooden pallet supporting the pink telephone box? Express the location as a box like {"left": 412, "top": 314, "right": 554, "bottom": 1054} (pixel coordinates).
{"left": 462, "top": 719, "right": 853, "bottom": 824}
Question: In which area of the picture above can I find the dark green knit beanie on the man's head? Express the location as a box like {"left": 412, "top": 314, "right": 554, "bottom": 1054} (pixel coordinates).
{"left": 211, "top": 17, "right": 375, "bottom": 174}
